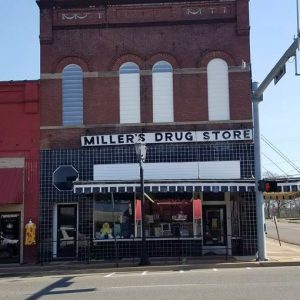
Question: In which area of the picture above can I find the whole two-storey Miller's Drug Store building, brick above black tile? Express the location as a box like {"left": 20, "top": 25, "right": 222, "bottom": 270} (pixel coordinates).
{"left": 37, "top": 0, "right": 256, "bottom": 261}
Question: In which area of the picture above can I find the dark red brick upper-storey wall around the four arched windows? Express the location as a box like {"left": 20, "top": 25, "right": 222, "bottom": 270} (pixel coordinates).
{"left": 39, "top": 0, "right": 252, "bottom": 149}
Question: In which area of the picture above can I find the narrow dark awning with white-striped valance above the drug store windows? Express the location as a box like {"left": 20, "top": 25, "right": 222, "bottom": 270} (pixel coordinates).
{"left": 74, "top": 180, "right": 255, "bottom": 194}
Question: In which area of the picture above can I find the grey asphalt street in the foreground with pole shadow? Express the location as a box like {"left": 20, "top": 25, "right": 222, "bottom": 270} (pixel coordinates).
{"left": 0, "top": 266, "right": 300, "bottom": 300}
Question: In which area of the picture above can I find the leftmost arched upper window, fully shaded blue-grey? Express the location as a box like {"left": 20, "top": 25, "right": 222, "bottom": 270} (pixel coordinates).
{"left": 62, "top": 64, "right": 83, "bottom": 125}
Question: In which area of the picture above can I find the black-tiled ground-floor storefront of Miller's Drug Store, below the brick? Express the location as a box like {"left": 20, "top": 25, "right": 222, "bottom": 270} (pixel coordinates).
{"left": 40, "top": 131, "right": 256, "bottom": 261}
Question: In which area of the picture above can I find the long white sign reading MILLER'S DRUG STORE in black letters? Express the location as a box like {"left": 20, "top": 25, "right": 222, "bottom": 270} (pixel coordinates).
{"left": 81, "top": 129, "right": 252, "bottom": 147}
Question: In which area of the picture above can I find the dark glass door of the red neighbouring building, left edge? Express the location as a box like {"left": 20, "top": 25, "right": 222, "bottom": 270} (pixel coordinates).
{"left": 0, "top": 213, "right": 20, "bottom": 263}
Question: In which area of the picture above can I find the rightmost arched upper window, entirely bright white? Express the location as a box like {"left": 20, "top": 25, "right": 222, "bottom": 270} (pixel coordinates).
{"left": 207, "top": 58, "right": 230, "bottom": 121}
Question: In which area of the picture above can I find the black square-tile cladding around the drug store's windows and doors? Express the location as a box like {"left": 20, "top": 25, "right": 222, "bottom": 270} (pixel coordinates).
{"left": 39, "top": 143, "right": 256, "bottom": 262}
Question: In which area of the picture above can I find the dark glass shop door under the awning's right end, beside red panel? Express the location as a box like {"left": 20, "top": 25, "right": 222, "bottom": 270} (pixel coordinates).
{"left": 203, "top": 205, "right": 227, "bottom": 246}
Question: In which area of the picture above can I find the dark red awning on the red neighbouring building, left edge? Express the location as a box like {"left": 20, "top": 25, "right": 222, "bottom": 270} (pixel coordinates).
{"left": 0, "top": 168, "right": 23, "bottom": 204}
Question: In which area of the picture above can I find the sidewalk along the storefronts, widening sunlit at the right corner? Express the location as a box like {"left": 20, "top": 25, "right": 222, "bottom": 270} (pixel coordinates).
{"left": 0, "top": 238, "right": 300, "bottom": 277}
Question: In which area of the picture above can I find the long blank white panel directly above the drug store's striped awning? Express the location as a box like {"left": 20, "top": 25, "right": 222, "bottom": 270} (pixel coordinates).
{"left": 94, "top": 161, "right": 241, "bottom": 181}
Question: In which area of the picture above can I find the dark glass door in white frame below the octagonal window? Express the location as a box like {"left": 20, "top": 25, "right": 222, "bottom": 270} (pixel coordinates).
{"left": 57, "top": 205, "right": 77, "bottom": 257}
